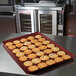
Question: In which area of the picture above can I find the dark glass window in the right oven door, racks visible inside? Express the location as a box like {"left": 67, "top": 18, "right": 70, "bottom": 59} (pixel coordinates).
{"left": 40, "top": 14, "right": 52, "bottom": 34}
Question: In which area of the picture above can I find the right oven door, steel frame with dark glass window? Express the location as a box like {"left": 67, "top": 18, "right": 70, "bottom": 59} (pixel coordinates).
{"left": 38, "top": 10, "right": 57, "bottom": 35}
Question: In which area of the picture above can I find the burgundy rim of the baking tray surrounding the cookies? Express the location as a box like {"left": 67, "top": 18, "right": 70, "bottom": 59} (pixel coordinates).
{"left": 3, "top": 32, "right": 75, "bottom": 74}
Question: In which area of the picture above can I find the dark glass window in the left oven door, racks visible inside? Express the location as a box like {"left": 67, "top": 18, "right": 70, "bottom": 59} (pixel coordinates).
{"left": 20, "top": 14, "right": 32, "bottom": 32}
